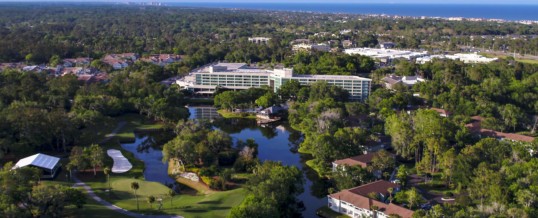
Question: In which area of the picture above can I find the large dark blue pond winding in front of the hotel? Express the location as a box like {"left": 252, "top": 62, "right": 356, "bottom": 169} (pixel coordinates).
{"left": 189, "top": 107, "right": 327, "bottom": 217}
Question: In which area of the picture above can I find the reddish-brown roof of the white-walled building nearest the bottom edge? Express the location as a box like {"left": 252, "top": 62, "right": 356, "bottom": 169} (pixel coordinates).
{"left": 329, "top": 180, "right": 414, "bottom": 218}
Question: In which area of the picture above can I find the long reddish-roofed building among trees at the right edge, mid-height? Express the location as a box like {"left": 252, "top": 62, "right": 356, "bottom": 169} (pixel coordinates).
{"left": 465, "top": 116, "right": 534, "bottom": 142}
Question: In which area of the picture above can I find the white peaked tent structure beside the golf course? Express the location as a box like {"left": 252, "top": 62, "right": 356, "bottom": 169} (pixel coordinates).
{"left": 12, "top": 153, "right": 61, "bottom": 178}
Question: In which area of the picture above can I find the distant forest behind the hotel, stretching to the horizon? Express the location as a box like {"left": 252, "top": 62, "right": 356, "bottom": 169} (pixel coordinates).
{"left": 0, "top": 3, "right": 538, "bottom": 64}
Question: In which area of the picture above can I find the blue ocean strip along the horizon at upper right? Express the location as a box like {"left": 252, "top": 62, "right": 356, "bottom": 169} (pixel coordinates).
{"left": 166, "top": 2, "right": 538, "bottom": 21}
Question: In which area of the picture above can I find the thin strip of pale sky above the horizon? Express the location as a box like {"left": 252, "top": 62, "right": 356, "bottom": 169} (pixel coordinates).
{"left": 0, "top": 0, "right": 538, "bottom": 5}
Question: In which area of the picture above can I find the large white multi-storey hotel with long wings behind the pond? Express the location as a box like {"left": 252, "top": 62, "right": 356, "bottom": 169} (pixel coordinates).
{"left": 176, "top": 63, "right": 372, "bottom": 101}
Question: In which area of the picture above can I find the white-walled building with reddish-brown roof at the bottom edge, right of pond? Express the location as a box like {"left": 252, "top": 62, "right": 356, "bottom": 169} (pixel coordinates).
{"left": 327, "top": 180, "right": 414, "bottom": 218}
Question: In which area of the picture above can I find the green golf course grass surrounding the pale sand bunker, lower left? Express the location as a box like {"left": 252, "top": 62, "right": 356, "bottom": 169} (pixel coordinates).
{"left": 73, "top": 114, "right": 245, "bottom": 217}
